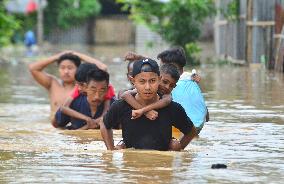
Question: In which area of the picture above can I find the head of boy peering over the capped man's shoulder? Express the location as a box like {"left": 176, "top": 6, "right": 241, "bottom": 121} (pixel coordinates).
{"left": 159, "top": 64, "right": 180, "bottom": 95}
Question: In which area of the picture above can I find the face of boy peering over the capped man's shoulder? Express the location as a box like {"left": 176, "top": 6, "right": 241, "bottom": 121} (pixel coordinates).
{"left": 159, "top": 73, "right": 177, "bottom": 95}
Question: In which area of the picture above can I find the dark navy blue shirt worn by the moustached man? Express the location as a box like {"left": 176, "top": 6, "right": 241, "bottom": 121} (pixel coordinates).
{"left": 55, "top": 94, "right": 114, "bottom": 130}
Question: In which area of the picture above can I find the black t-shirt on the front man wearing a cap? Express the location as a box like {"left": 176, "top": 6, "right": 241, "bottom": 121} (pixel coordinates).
{"left": 104, "top": 100, "right": 193, "bottom": 150}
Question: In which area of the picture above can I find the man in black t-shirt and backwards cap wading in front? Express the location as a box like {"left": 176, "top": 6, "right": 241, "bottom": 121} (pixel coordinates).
{"left": 100, "top": 59, "right": 193, "bottom": 150}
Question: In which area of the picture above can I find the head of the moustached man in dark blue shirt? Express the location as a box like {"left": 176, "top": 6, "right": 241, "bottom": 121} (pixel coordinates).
{"left": 86, "top": 69, "right": 109, "bottom": 106}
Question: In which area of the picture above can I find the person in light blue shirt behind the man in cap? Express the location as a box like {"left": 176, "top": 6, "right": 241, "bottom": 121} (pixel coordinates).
{"left": 125, "top": 47, "right": 209, "bottom": 134}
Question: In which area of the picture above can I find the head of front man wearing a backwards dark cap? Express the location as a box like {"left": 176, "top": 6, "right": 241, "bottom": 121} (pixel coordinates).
{"left": 132, "top": 59, "right": 160, "bottom": 103}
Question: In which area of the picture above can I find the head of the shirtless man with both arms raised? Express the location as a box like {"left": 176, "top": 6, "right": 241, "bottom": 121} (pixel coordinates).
{"left": 57, "top": 53, "right": 81, "bottom": 83}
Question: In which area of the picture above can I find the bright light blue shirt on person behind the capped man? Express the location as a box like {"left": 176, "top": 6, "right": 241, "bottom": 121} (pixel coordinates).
{"left": 172, "top": 79, "right": 207, "bottom": 129}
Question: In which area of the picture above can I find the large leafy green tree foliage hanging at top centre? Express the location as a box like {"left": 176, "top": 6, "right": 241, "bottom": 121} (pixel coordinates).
{"left": 117, "top": 0, "right": 215, "bottom": 63}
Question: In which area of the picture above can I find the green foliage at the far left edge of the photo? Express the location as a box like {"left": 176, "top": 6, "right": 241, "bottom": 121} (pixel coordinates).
{"left": 0, "top": 1, "right": 20, "bottom": 47}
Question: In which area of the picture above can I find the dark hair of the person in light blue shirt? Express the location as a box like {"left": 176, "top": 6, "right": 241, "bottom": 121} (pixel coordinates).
{"left": 157, "top": 47, "right": 186, "bottom": 68}
